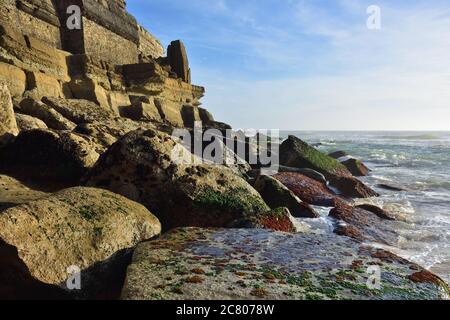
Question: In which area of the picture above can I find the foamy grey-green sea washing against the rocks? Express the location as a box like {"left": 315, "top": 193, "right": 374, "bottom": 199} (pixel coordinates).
{"left": 281, "top": 131, "right": 450, "bottom": 283}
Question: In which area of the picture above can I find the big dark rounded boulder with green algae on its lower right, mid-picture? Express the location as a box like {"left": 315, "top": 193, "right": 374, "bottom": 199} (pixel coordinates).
{"left": 85, "top": 129, "right": 290, "bottom": 231}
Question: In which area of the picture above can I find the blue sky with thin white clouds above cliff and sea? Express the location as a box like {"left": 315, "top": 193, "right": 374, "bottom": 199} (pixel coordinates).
{"left": 127, "top": 0, "right": 450, "bottom": 131}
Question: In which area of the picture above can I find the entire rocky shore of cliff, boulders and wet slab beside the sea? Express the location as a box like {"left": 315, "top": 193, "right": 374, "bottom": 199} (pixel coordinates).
{"left": 0, "top": 0, "right": 450, "bottom": 300}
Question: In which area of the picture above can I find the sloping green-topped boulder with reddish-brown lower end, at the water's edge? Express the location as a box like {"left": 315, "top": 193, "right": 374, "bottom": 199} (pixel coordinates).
{"left": 280, "top": 136, "right": 378, "bottom": 198}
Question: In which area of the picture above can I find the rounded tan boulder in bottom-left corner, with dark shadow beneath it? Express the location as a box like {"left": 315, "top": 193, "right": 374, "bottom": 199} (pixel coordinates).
{"left": 0, "top": 187, "right": 161, "bottom": 299}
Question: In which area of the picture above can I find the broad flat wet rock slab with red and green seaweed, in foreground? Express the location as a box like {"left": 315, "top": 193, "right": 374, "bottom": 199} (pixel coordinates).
{"left": 122, "top": 228, "right": 448, "bottom": 300}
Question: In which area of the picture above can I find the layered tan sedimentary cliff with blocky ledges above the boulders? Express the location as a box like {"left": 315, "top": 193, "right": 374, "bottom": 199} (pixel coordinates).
{"left": 0, "top": 0, "right": 214, "bottom": 131}
